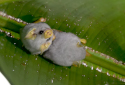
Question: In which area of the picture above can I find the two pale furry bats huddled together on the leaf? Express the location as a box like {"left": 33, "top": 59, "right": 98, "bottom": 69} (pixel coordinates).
{"left": 21, "top": 18, "right": 86, "bottom": 66}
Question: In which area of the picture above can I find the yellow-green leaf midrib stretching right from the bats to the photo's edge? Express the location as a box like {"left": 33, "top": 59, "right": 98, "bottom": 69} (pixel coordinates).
{"left": 85, "top": 49, "right": 125, "bottom": 76}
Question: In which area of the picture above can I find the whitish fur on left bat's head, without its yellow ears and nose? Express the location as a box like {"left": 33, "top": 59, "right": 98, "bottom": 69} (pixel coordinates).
{"left": 21, "top": 23, "right": 53, "bottom": 54}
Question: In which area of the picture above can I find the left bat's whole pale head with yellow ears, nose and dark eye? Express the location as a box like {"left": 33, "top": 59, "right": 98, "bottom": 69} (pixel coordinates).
{"left": 22, "top": 23, "right": 53, "bottom": 53}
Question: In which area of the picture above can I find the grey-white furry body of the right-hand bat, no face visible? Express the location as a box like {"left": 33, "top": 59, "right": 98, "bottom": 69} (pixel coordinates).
{"left": 44, "top": 30, "right": 86, "bottom": 66}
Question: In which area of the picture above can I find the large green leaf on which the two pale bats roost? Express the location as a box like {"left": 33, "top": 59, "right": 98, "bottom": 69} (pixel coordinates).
{"left": 0, "top": 0, "right": 125, "bottom": 85}
